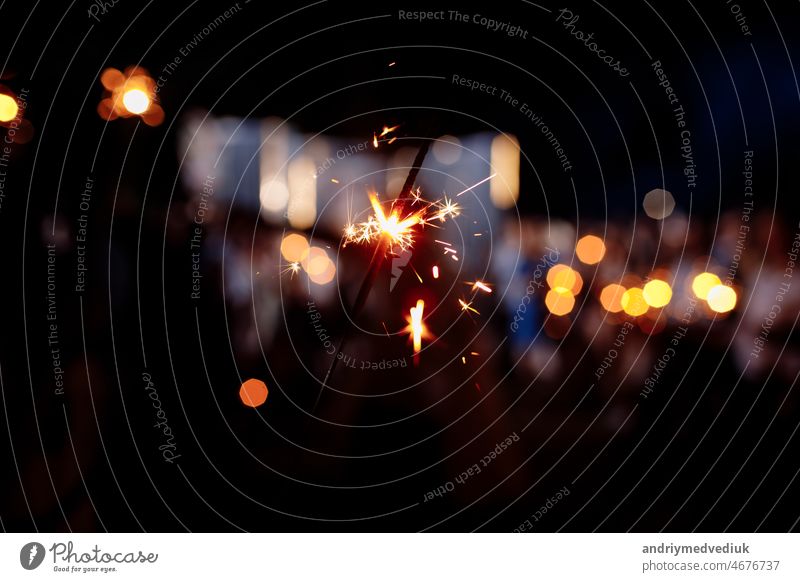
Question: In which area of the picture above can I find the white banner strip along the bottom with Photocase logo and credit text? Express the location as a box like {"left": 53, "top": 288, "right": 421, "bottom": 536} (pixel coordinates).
{"left": 0, "top": 534, "right": 800, "bottom": 582}
